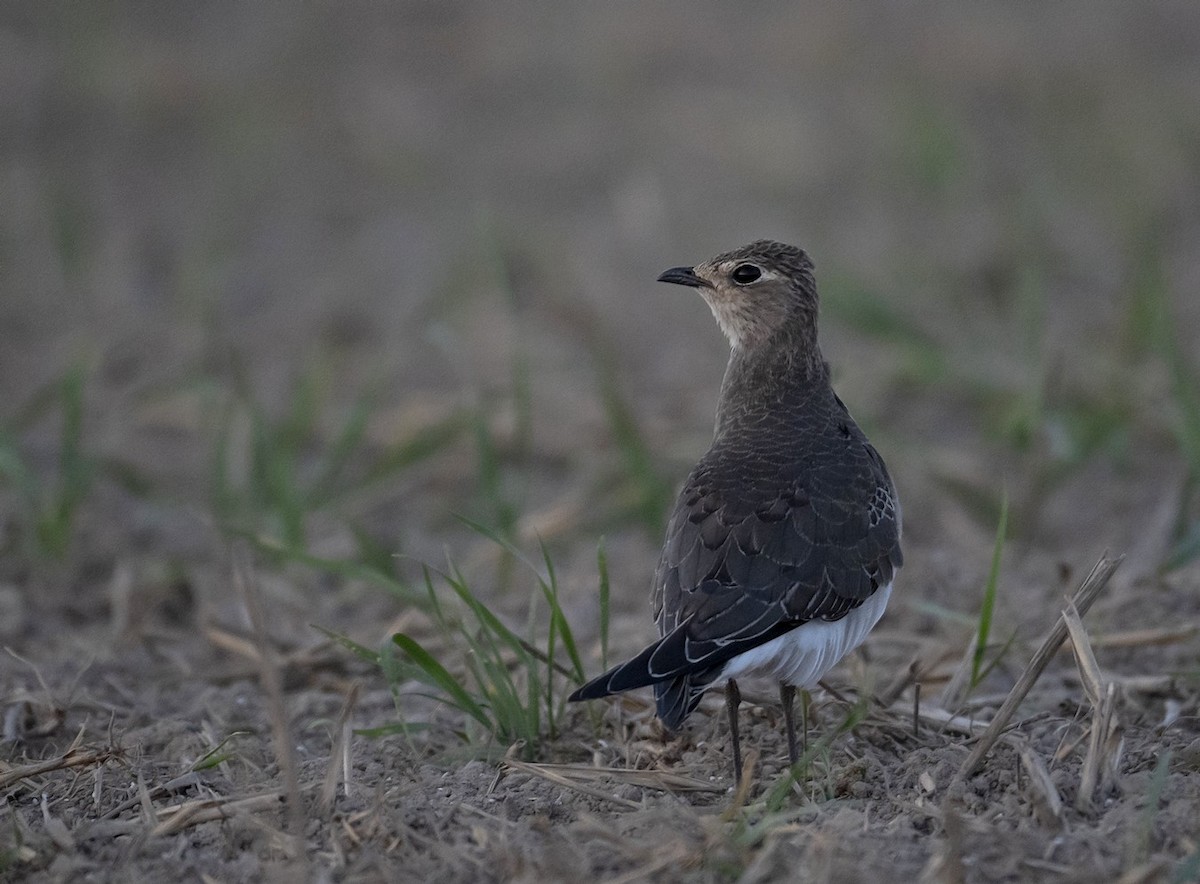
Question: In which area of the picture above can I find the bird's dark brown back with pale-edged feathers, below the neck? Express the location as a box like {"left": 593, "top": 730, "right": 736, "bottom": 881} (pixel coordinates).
{"left": 647, "top": 377, "right": 901, "bottom": 727}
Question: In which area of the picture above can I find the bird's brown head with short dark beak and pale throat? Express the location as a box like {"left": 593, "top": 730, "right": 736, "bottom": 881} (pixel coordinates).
{"left": 659, "top": 240, "right": 817, "bottom": 350}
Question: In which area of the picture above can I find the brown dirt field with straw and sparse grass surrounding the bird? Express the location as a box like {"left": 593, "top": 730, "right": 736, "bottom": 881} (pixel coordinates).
{"left": 0, "top": 2, "right": 1200, "bottom": 882}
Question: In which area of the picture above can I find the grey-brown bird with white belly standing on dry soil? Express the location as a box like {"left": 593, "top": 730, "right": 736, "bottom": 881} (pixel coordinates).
{"left": 569, "top": 240, "right": 904, "bottom": 784}
